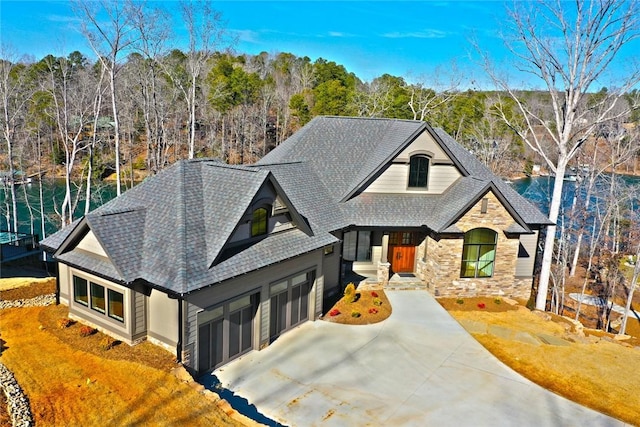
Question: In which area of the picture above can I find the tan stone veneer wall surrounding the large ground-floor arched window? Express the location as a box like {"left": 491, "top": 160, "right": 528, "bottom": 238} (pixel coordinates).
{"left": 417, "top": 192, "right": 532, "bottom": 298}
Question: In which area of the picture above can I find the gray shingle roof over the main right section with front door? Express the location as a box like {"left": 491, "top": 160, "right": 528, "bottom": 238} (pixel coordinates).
{"left": 257, "top": 117, "right": 549, "bottom": 231}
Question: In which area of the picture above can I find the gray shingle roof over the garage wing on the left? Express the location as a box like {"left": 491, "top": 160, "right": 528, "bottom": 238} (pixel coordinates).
{"left": 49, "top": 160, "right": 337, "bottom": 294}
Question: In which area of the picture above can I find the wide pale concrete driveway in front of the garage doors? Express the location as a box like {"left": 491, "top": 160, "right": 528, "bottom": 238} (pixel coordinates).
{"left": 203, "top": 291, "right": 624, "bottom": 427}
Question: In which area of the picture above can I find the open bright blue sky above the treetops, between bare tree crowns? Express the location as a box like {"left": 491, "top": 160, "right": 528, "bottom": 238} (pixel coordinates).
{"left": 0, "top": 0, "right": 636, "bottom": 87}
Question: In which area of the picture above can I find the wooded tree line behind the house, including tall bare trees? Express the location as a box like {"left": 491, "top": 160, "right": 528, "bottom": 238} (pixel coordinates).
{"left": 0, "top": 0, "right": 640, "bottom": 320}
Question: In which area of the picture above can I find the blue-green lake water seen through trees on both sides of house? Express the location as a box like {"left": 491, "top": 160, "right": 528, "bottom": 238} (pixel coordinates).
{"left": 0, "top": 175, "right": 640, "bottom": 238}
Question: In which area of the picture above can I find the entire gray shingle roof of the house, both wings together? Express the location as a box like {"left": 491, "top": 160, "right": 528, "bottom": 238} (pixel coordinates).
{"left": 42, "top": 117, "right": 549, "bottom": 294}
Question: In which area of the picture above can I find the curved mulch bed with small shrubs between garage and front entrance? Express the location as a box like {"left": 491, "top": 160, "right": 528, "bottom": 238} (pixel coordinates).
{"left": 322, "top": 290, "right": 392, "bottom": 325}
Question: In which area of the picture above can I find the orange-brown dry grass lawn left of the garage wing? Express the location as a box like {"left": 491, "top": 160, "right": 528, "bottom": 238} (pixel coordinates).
{"left": 0, "top": 279, "right": 241, "bottom": 426}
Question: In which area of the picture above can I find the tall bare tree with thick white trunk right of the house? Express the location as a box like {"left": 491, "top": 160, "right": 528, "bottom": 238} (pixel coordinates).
{"left": 484, "top": 0, "right": 640, "bottom": 310}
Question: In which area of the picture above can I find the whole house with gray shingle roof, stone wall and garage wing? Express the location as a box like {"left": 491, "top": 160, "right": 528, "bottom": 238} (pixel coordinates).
{"left": 41, "top": 117, "right": 549, "bottom": 373}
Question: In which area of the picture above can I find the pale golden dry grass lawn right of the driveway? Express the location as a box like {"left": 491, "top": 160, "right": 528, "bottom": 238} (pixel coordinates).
{"left": 439, "top": 298, "right": 640, "bottom": 425}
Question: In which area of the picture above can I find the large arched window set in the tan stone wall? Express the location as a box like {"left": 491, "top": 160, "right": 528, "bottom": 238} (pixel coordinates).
{"left": 460, "top": 228, "right": 498, "bottom": 277}
